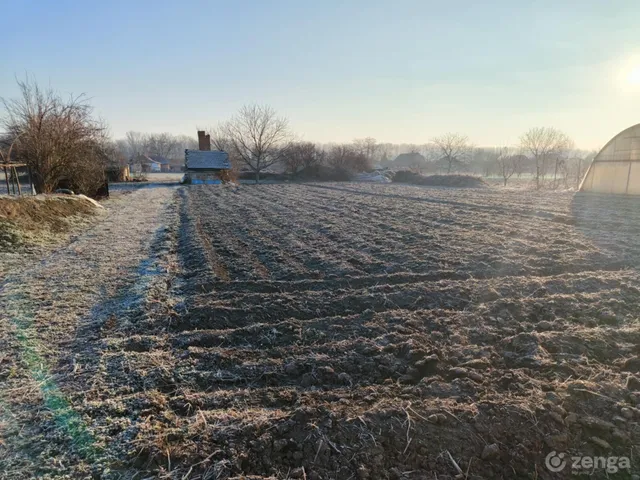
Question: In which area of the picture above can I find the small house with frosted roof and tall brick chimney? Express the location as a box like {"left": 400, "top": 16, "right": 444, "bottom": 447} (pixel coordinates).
{"left": 184, "top": 131, "right": 231, "bottom": 184}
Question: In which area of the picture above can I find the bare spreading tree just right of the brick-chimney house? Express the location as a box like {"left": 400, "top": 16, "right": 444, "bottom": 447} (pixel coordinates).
{"left": 219, "top": 105, "right": 291, "bottom": 183}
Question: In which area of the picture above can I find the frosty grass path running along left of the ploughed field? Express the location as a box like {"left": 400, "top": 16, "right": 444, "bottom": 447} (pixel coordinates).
{"left": 0, "top": 185, "right": 177, "bottom": 478}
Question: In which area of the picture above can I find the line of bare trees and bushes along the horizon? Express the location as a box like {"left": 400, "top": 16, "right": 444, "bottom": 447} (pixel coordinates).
{"left": 0, "top": 78, "right": 595, "bottom": 193}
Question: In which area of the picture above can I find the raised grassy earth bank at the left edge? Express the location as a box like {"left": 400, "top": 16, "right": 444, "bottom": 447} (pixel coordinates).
{"left": 0, "top": 195, "right": 98, "bottom": 251}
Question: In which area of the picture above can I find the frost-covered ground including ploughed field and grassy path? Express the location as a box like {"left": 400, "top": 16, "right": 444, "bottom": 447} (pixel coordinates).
{"left": 0, "top": 184, "right": 640, "bottom": 479}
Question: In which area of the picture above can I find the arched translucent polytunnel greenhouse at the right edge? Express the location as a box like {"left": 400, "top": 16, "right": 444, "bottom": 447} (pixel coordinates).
{"left": 580, "top": 124, "right": 640, "bottom": 195}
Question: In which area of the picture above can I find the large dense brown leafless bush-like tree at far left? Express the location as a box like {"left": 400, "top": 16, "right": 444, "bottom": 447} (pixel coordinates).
{"left": 2, "top": 78, "right": 107, "bottom": 194}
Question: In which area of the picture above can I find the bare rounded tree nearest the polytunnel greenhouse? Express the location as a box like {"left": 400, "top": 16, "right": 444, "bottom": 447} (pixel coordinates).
{"left": 520, "top": 127, "right": 573, "bottom": 189}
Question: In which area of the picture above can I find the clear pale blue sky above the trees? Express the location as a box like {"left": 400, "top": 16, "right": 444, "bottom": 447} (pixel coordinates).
{"left": 0, "top": 0, "right": 640, "bottom": 148}
